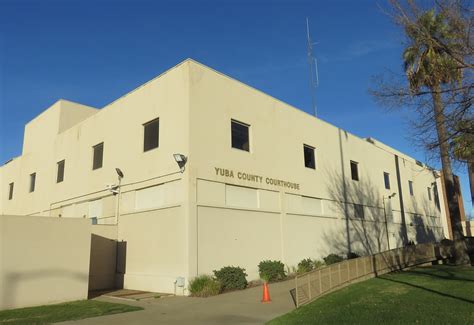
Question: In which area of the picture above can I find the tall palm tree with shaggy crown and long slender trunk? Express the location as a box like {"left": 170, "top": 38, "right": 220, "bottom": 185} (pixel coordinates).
{"left": 403, "top": 10, "right": 467, "bottom": 262}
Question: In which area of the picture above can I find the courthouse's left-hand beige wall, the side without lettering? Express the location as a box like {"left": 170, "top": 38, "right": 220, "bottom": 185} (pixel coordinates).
{"left": 0, "top": 62, "right": 189, "bottom": 292}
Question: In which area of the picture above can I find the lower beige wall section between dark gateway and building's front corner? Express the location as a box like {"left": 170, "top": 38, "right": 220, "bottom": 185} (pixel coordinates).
{"left": 119, "top": 205, "right": 187, "bottom": 293}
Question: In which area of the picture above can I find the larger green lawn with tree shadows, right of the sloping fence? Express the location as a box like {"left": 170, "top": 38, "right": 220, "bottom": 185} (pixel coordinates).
{"left": 269, "top": 265, "right": 474, "bottom": 325}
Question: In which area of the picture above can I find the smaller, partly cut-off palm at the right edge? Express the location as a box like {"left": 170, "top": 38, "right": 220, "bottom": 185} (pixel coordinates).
{"left": 451, "top": 119, "right": 474, "bottom": 217}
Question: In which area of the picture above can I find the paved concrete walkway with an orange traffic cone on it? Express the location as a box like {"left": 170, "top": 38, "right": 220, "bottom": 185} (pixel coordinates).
{"left": 61, "top": 280, "right": 295, "bottom": 325}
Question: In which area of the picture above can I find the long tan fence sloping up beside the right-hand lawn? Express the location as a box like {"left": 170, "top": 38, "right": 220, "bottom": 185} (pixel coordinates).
{"left": 295, "top": 243, "right": 441, "bottom": 308}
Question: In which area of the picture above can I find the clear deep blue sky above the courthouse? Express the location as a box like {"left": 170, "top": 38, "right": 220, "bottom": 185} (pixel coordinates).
{"left": 0, "top": 0, "right": 470, "bottom": 215}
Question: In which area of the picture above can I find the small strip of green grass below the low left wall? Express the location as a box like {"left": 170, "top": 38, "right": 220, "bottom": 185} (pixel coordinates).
{"left": 0, "top": 300, "right": 143, "bottom": 324}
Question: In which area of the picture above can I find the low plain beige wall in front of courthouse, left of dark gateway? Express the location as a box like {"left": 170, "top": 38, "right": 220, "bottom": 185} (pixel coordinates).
{"left": 0, "top": 216, "right": 91, "bottom": 309}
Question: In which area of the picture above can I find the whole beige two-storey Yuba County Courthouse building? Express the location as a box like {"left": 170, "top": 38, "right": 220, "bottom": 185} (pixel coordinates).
{"left": 0, "top": 59, "right": 448, "bottom": 294}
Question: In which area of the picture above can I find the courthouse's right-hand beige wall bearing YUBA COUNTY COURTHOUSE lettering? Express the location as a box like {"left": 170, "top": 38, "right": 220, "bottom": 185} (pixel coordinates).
{"left": 188, "top": 59, "right": 444, "bottom": 278}
